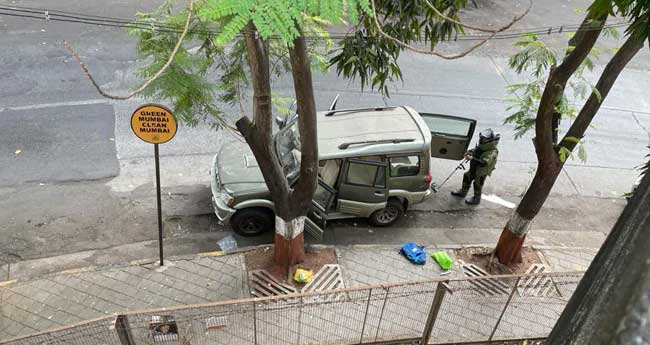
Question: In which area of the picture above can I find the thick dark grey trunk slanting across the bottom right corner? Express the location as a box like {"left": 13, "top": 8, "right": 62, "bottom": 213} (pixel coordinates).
{"left": 546, "top": 174, "right": 650, "bottom": 345}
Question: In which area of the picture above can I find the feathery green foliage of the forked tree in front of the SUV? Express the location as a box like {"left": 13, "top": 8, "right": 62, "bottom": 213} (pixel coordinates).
{"left": 130, "top": 0, "right": 370, "bottom": 127}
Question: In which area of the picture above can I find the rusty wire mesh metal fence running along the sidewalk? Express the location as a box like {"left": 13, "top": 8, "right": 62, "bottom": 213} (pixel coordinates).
{"left": 0, "top": 272, "right": 582, "bottom": 345}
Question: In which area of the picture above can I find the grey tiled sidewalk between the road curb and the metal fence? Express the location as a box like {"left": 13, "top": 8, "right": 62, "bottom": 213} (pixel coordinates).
{"left": 0, "top": 246, "right": 597, "bottom": 340}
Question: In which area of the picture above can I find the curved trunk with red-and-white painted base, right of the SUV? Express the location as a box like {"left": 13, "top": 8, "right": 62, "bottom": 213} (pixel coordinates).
{"left": 495, "top": 12, "right": 607, "bottom": 265}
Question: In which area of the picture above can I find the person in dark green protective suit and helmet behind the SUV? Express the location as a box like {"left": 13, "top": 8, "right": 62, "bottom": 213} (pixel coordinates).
{"left": 451, "top": 128, "right": 500, "bottom": 205}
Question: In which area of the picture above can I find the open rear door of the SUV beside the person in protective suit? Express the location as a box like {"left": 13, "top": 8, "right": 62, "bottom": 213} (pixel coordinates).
{"left": 420, "top": 113, "right": 476, "bottom": 160}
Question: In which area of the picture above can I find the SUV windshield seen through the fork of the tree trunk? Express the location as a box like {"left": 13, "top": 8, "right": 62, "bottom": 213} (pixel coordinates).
{"left": 275, "top": 115, "right": 300, "bottom": 180}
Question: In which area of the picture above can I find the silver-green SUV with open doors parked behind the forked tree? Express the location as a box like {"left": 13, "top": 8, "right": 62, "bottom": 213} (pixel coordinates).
{"left": 211, "top": 106, "right": 476, "bottom": 239}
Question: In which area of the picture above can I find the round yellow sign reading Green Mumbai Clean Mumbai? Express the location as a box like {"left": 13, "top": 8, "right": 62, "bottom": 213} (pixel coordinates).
{"left": 131, "top": 104, "right": 176, "bottom": 144}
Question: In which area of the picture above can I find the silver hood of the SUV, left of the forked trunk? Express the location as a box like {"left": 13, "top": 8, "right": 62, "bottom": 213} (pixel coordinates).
{"left": 217, "top": 141, "right": 267, "bottom": 193}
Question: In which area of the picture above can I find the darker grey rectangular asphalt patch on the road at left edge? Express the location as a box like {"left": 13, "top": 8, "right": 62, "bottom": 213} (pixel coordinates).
{"left": 0, "top": 104, "right": 119, "bottom": 186}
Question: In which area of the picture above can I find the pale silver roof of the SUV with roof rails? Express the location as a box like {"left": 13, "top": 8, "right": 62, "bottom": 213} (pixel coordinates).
{"left": 317, "top": 106, "right": 431, "bottom": 159}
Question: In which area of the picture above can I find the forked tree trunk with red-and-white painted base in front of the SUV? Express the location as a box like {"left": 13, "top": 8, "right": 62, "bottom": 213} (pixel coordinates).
{"left": 237, "top": 28, "right": 318, "bottom": 269}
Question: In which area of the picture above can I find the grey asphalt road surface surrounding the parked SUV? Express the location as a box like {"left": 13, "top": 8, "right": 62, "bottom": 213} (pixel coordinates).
{"left": 0, "top": 0, "right": 650, "bottom": 261}
